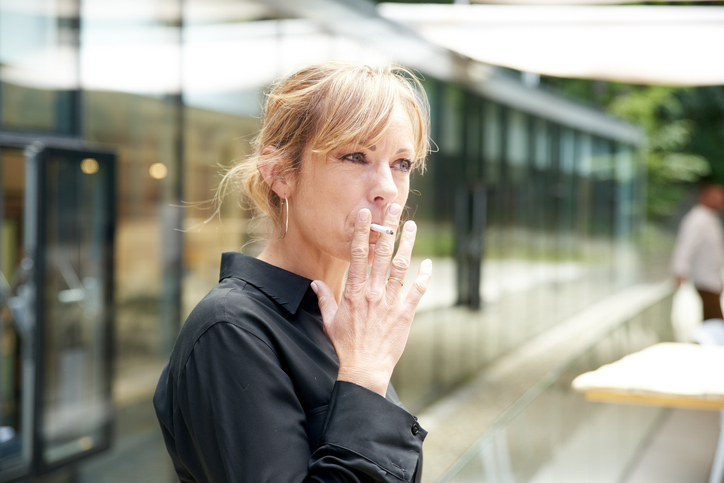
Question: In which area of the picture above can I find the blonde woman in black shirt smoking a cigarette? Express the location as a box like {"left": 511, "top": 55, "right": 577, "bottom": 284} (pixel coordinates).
{"left": 154, "top": 63, "right": 431, "bottom": 483}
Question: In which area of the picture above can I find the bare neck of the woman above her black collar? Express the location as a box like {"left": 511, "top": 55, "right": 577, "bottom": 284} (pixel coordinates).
{"left": 258, "top": 232, "right": 349, "bottom": 303}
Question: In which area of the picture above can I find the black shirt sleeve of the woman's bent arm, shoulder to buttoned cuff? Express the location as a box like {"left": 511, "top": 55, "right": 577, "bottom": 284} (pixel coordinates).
{"left": 174, "top": 323, "right": 426, "bottom": 483}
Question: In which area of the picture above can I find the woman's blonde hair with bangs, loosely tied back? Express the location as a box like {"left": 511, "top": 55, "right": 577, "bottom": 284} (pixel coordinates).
{"left": 216, "top": 62, "right": 430, "bottom": 235}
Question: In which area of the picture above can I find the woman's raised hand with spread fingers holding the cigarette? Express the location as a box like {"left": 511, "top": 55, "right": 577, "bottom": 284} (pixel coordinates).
{"left": 312, "top": 203, "right": 432, "bottom": 396}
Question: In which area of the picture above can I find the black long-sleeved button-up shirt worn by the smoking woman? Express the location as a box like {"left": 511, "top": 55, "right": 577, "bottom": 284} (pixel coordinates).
{"left": 153, "top": 253, "right": 427, "bottom": 483}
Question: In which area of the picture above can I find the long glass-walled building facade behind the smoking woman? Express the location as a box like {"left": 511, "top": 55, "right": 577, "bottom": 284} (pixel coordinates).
{"left": 0, "top": 0, "right": 645, "bottom": 482}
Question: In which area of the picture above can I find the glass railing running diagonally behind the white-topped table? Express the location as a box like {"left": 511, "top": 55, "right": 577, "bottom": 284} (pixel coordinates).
{"left": 439, "top": 297, "right": 673, "bottom": 483}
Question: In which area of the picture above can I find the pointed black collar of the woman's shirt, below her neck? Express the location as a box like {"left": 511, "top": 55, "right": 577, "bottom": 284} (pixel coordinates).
{"left": 219, "top": 252, "right": 312, "bottom": 314}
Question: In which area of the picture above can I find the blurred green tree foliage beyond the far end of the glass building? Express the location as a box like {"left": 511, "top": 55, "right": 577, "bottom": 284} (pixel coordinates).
{"left": 543, "top": 78, "right": 724, "bottom": 221}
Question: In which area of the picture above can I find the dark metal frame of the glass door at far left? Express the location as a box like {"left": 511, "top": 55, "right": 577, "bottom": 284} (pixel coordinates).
{"left": 0, "top": 133, "right": 117, "bottom": 481}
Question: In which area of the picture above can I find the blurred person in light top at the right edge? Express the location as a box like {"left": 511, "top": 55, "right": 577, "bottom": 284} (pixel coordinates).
{"left": 672, "top": 183, "right": 724, "bottom": 321}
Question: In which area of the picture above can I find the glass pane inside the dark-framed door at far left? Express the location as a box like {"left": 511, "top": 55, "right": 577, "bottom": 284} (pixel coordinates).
{"left": 38, "top": 150, "right": 114, "bottom": 465}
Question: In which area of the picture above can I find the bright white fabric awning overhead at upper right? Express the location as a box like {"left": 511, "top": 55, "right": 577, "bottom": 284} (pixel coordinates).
{"left": 379, "top": 3, "right": 724, "bottom": 86}
